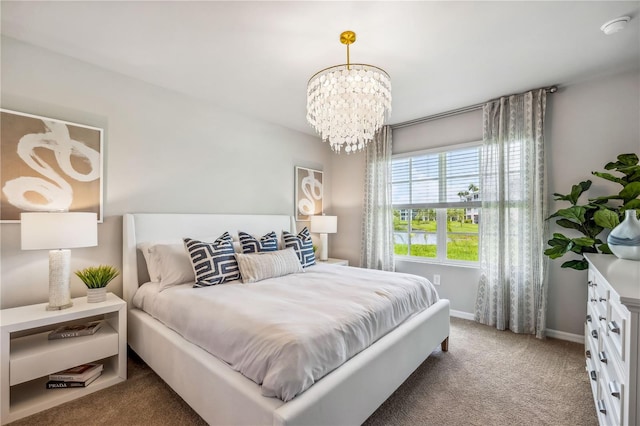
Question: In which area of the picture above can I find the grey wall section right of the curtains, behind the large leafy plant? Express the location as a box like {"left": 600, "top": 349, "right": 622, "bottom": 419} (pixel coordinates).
{"left": 547, "top": 70, "right": 640, "bottom": 334}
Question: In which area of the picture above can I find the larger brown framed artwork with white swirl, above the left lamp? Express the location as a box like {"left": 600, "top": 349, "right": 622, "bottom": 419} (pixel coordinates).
{"left": 0, "top": 109, "right": 103, "bottom": 223}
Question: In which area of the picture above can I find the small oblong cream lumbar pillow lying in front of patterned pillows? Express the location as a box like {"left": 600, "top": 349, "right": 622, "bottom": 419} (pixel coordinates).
{"left": 236, "top": 248, "right": 302, "bottom": 283}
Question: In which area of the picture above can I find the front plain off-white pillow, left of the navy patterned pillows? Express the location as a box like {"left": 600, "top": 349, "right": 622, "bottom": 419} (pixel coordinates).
{"left": 149, "top": 243, "right": 195, "bottom": 291}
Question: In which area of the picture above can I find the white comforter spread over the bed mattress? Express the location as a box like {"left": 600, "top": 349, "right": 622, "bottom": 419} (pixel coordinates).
{"left": 133, "top": 265, "right": 438, "bottom": 401}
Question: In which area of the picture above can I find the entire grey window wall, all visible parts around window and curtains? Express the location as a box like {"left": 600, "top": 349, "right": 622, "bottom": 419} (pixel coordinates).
{"left": 331, "top": 70, "right": 640, "bottom": 335}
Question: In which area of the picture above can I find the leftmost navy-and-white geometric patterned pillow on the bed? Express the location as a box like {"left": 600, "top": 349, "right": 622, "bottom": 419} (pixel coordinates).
{"left": 183, "top": 232, "right": 240, "bottom": 287}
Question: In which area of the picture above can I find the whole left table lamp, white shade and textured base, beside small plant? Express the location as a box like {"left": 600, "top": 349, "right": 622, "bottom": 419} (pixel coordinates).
{"left": 20, "top": 212, "right": 98, "bottom": 311}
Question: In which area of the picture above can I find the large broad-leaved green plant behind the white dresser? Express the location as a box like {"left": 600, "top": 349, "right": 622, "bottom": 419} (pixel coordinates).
{"left": 544, "top": 154, "right": 640, "bottom": 270}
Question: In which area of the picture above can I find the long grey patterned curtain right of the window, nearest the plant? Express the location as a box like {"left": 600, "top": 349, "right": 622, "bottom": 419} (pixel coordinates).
{"left": 475, "top": 89, "right": 547, "bottom": 338}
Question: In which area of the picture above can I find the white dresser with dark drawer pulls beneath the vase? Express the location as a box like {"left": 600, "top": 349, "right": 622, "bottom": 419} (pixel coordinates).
{"left": 585, "top": 254, "right": 640, "bottom": 426}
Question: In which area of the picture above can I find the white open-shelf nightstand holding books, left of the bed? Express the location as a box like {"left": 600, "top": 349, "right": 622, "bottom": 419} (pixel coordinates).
{"left": 0, "top": 293, "right": 127, "bottom": 424}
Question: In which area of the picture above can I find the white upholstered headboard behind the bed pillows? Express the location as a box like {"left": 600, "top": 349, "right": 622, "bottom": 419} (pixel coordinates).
{"left": 122, "top": 213, "right": 296, "bottom": 306}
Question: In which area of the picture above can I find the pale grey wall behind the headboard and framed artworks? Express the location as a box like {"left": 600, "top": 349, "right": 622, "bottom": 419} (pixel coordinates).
{"left": 0, "top": 38, "right": 332, "bottom": 308}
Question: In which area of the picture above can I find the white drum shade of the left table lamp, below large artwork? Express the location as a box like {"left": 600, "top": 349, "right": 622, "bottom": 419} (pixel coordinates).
{"left": 20, "top": 212, "right": 98, "bottom": 250}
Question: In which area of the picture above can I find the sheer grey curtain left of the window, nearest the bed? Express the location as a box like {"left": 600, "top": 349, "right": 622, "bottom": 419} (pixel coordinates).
{"left": 360, "top": 126, "right": 395, "bottom": 271}
